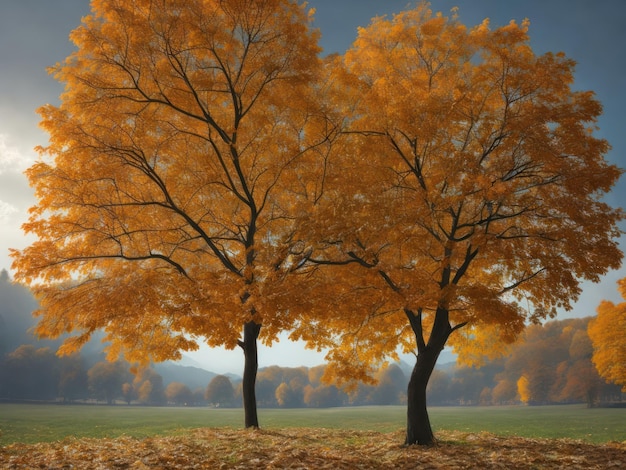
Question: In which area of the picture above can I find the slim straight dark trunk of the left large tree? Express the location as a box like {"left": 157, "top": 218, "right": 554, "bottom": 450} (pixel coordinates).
{"left": 239, "top": 320, "right": 261, "bottom": 428}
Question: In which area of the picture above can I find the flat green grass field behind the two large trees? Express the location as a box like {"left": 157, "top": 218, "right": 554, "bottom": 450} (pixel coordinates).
{"left": 0, "top": 404, "right": 626, "bottom": 446}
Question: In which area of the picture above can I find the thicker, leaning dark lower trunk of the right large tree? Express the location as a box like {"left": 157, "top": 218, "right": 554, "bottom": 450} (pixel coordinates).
{"left": 404, "top": 347, "right": 441, "bottom": 446}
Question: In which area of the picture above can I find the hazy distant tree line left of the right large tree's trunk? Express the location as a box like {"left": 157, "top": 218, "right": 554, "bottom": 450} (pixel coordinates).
{"left": 0, "top": 344, "right": 406, "bottom": 408}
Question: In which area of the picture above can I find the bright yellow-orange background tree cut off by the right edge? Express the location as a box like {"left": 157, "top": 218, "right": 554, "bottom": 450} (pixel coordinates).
{"left": 588, "top": 278, "right": 626, "bottom": 391}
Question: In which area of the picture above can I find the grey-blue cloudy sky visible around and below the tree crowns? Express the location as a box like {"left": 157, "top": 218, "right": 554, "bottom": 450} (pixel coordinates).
{"left": 0, "top": 0, "right": 626, "bottom": 373}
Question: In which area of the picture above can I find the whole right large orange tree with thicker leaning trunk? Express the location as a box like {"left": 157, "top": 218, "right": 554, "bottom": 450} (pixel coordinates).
{"left": 298, "top": 4, "right": 623, "bottom": 445}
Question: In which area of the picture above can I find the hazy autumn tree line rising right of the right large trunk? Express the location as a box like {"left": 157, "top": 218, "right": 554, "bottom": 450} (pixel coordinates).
{"left": 428, "top": 317, "right": 622, "bottom": 407}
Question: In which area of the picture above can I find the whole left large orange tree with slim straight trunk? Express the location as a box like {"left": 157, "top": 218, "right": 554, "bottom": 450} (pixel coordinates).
{"left": 13, "top": 0, "right": 328, "bottom": 427}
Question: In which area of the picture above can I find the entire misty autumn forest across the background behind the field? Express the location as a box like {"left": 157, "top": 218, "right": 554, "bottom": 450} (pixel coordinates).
{"left": 0, "top": 270, "right": 621, "bottom": 408}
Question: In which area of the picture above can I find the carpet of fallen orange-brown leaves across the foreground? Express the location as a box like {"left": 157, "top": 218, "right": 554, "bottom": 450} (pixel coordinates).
{"left": 0, "top": 428, "right": 626, "bottom": 470}
